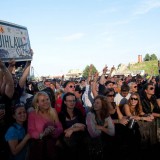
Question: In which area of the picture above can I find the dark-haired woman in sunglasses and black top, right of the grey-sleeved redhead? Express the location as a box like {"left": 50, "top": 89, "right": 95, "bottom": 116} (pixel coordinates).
{"left": 105, "top": 88, "right": 142, "bottom": 153}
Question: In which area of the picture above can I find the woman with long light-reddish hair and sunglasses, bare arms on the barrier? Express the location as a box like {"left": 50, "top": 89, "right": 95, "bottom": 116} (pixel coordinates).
{"left": 124, "top": 93, "right": 154, "bottom": 150}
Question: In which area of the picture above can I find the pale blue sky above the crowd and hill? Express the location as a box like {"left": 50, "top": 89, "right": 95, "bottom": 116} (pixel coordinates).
{"left": 0, "top": 0, "right": 160, "bottom": 76}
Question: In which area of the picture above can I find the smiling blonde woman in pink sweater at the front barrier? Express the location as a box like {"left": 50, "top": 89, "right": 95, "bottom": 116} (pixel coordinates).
{"left": 28, "top": 92, "right": 63, "bottom": 160}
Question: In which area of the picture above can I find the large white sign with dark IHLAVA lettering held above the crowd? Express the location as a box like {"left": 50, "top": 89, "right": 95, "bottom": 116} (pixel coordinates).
{"left": 0, "top": 21, "right": 33, "bottom": 62}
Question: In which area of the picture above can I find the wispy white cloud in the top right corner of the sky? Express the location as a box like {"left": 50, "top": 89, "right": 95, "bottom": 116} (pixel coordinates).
{"left": 134, "top": 0, "right": 160, "bottom": 15}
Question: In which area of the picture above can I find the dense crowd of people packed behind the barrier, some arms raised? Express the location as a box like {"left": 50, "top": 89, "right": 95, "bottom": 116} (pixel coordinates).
{"left": 0, "top": 59, "right": 160, "bottom": 160}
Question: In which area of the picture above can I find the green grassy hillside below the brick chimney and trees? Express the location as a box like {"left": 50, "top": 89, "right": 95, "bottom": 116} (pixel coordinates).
{"left": 127, "top": 60, "right": 159, "bottom": 75}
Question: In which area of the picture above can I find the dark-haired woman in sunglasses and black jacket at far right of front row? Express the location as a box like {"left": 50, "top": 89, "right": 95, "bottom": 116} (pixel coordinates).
{"left": 141, "top": 83, "right": 160, "bottom": 146}
